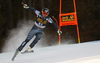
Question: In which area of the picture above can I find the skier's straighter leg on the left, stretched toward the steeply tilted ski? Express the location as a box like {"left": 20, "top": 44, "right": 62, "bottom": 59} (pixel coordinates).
{"left": 18, "top": 30, "right": 35, "bottom": 51}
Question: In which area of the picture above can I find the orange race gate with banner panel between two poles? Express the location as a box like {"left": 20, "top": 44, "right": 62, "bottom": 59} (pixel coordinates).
{"left": 59, "top": 0, "right": 80, "bottom": 44}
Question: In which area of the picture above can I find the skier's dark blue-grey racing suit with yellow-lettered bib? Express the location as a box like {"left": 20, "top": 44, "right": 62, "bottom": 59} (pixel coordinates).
{"left": 18, "top": 7, "right": 59, "bottom": 51}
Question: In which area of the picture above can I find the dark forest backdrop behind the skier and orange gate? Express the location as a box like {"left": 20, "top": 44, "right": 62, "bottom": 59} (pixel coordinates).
{"left": 0, "top": 0, "right": 100, "bottom": 52}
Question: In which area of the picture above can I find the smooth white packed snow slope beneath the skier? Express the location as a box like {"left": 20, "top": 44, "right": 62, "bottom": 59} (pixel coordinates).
{"left": 0, "top": 41, "right": 100, "bottom": 63}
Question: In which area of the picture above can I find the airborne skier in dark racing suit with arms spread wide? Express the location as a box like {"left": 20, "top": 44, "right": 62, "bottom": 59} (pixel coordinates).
{"left": 14, "top": 4, "right": 62, "bottom": 55}
